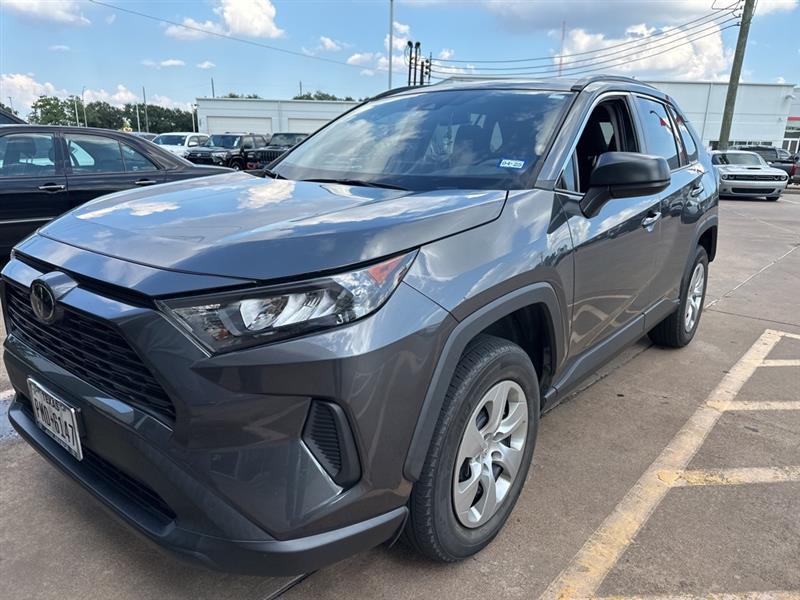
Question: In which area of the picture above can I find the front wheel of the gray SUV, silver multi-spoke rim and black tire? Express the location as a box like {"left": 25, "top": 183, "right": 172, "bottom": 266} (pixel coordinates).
{"left": 404, "top": 335, "right": 539, "bottom": 562}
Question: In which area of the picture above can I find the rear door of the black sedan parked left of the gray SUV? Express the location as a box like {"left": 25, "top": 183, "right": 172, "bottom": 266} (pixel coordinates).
{"left": 64, "top": 133, "right": 164, "bottom": 206}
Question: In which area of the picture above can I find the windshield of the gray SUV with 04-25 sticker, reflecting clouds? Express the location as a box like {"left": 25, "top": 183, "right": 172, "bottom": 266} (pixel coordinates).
{"left": 273, "top": 90, "right": 572, "bottom": 190}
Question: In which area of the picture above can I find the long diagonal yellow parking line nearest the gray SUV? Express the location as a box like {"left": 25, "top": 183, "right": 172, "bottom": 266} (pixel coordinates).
{"left": 541, "top": 329, "right": 782, "bottom": 600}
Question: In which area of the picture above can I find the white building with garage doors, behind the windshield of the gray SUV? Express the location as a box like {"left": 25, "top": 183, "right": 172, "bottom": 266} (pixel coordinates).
{"left": 197, "top": 98, "right": 358, "bottom": 133}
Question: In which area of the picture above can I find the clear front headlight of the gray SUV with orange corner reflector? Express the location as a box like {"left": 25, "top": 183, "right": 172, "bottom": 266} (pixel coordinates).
{"left": 158, "top": 251, "right": 416, "bottom": 353}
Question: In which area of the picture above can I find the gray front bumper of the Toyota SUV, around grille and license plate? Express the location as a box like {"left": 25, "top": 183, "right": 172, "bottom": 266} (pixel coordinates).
{"left": 3, "top": 239, "right": 455, "bottom": 575}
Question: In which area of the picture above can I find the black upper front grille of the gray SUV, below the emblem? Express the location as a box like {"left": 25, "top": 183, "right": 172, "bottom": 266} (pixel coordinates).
{"left": 5, "top": 282, "right": 175, "bottom": 423}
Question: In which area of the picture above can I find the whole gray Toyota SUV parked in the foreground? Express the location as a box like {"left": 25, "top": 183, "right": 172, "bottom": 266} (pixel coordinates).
{"left": 2, "top": 77, "right": 718, "bottom": 574}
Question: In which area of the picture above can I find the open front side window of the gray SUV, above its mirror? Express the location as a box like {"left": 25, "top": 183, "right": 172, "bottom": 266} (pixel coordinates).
{"left": 557, "top": 98, "right": 638, "bottom": 194}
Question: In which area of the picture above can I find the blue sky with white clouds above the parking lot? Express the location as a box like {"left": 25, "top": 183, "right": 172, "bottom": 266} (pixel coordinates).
{"left": 0, "top": 0, "right": 800, "bottom": 114}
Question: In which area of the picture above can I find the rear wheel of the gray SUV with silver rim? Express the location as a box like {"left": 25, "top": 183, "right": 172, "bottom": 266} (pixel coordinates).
{"left": 648, "top": 246, "right": 708, "bottom": 348}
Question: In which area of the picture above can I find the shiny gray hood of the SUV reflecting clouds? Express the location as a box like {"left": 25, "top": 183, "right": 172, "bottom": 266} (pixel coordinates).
{"left": 39, "top": 173, "right": 506, "bottom": 280}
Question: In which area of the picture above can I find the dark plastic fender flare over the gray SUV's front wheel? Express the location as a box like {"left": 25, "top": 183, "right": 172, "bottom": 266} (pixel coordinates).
{"left": 403, "top": 282, "right": 564, "bottom": 481}
